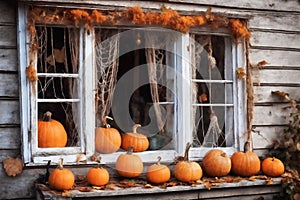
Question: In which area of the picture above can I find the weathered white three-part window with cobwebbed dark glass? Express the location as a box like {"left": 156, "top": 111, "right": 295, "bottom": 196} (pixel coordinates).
{"left": 19, "top": 5, "right": 245, "bottom": 166}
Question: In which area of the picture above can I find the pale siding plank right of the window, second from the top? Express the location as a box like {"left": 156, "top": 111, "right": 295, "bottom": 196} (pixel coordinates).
{"left": 249, "top": 13, "right": 300, "bottom": 32}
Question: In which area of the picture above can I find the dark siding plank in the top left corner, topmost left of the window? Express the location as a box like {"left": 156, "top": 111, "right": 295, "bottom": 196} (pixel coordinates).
{"left": 0, "top": 1, "right": 16, "bottom": 24}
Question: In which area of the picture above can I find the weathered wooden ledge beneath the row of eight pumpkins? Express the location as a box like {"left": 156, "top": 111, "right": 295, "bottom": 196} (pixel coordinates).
{"left": 36, "top": 178, "right": 282, "bottom": 200}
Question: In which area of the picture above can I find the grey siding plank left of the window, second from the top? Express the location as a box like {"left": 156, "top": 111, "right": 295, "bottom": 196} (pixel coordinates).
{"left": 0, "top": 26, "right": 17, "bottom": 47}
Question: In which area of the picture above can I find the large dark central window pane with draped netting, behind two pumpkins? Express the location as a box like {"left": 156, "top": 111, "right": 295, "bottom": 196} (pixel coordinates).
{"left": 95, "top": 29, "right": 174, "bottom": 150}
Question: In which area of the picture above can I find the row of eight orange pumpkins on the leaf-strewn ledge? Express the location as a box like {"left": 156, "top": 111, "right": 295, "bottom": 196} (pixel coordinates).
{"left": 38, "top": 142, "right": 284, "bottom": 196}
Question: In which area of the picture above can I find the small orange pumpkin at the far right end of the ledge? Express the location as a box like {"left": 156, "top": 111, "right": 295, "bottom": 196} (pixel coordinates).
{"left": 261, "top": 157, "right": 284, "bottom": 177}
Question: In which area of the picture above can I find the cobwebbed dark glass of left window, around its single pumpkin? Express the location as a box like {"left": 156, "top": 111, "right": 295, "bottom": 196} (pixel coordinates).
{"left": 36, "top": 26, "right": 80, "bottom": 146}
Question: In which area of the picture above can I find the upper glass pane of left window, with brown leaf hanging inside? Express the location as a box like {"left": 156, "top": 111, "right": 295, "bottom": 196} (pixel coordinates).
{"left": 36, "top": 26, "right": 79, "bottom": 73}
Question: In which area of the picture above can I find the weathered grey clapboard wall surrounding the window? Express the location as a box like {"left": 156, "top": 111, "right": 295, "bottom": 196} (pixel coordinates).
{"left": 0, "top": 0, "right": 300, "bottom": 199}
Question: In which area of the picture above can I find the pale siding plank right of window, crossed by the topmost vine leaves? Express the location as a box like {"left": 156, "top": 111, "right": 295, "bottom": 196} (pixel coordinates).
{"left": 253, "top": 86, "right": 300, "bottom": 103}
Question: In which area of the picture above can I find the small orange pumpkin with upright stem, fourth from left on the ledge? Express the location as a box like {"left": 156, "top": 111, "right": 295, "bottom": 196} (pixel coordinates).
{"left": 146, "top": 156, "right": 171, "bottom": 184}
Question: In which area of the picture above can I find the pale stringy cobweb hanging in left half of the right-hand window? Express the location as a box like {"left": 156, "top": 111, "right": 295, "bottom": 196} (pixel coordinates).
{"left": 192, "top": 35, "right": 225, "bottom": 147}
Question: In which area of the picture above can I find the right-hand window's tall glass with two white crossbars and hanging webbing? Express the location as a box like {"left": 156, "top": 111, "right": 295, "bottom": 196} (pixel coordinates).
{"left": 192, "top": 35, "right": 234, "bottom": 147}
